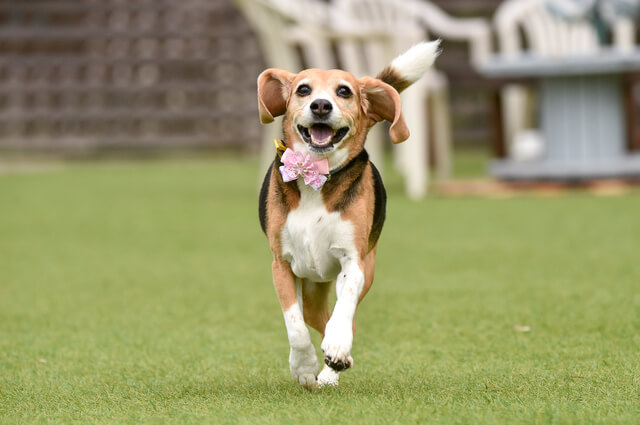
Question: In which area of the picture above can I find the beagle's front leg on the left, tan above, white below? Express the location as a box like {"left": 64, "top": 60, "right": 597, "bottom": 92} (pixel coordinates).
{"left": 272, "top": 259, "right": 318, "bottom": 389}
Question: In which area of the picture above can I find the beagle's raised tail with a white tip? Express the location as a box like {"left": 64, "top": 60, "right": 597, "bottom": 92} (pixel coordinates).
{"left": 376, "top": 40, "right": 440, "bottom": 93}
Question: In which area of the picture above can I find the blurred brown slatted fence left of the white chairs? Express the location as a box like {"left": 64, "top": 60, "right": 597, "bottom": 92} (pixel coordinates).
{"left": 0, "top": 0, "right": 263, "bottom": 155}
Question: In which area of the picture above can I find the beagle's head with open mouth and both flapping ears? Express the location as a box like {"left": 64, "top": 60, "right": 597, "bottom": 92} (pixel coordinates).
{"left": 258, "top": 69, "right": 409, "bottom": 167}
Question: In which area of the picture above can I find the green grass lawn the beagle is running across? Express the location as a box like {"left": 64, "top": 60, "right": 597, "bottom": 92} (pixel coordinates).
{"left": 0, "top": 158, "right": 640, "bottom": 425}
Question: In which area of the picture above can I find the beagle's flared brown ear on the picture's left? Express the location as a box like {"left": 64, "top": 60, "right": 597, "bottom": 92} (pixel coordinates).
{"left": 258, "top": 68, "right": 296, "bottom": 124}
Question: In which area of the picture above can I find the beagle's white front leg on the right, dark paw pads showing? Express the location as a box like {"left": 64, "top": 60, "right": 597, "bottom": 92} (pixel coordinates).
{"left": 321, "top": 253, "right": 365, "bottom": 376}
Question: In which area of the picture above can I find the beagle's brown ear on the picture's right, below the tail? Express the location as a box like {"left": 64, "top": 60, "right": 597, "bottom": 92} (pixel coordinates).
{"left": 359, "top": 77, "right": 409, "bottom": 143}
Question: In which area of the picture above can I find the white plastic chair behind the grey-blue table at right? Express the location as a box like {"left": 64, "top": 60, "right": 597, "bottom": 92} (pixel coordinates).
{"left": 493, "top": 0, "right": 635, "bottom": 157}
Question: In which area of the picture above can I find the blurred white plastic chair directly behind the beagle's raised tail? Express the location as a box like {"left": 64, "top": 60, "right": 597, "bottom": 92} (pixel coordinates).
{"left": 330, "top": 0, "right": 491, "bottom": 192}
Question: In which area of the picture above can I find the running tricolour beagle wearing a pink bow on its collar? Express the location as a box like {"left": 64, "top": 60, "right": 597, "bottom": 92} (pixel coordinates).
{"left": 258, "top": 41, "right": 439, "bottom": 389}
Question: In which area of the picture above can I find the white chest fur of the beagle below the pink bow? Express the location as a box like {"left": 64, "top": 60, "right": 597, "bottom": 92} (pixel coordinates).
{"left": 281, "top": 181, "right": 357, "bottom": 282}
